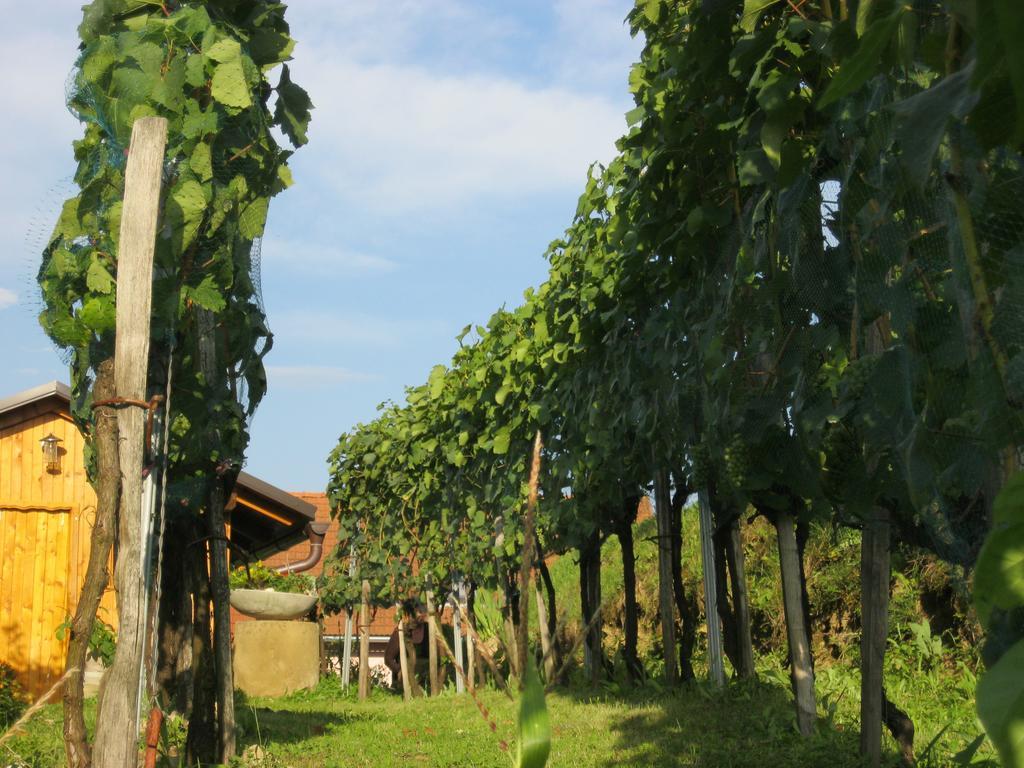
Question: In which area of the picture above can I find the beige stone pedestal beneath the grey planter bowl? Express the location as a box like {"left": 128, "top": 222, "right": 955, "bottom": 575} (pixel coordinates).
{"left": 233, "top": 621, "right": 319, "bottom": 696}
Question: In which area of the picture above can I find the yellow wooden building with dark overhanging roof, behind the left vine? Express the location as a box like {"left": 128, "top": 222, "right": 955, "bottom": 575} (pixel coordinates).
{"left": 0, "top": 382, "right": 315, "bottom": 696}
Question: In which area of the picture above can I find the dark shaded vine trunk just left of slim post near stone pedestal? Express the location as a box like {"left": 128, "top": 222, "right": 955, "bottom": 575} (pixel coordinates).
{"left": 185, "top": 525, "right": 218, "bottom": 765}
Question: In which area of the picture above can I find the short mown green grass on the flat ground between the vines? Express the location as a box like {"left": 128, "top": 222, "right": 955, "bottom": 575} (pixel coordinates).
{"left": 0, "top": 671, "right": 996, "bottom": 768}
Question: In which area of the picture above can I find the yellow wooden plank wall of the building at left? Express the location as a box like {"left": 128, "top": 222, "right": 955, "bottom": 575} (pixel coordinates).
{"left": 0, "top": 410, "right": 116, "bottom": 696}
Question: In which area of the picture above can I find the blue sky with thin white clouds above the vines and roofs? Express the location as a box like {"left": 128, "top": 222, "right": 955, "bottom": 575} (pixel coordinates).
{"left": 0, "top": 0, "right": 640, "bottom": 490}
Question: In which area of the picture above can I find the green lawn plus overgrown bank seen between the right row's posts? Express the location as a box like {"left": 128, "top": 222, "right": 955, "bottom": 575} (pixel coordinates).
{"left": 0, "top": 521, "right": 997, "bottom": 768}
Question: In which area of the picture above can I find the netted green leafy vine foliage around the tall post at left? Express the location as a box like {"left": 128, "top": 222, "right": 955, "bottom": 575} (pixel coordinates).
{"left": 38, "top": 0, "right": 311, "bottom": 512}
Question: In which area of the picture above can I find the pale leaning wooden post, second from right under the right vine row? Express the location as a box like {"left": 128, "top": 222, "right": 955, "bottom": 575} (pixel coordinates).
{"left": 775, "top": 513, "right": 817, "bottom": 736}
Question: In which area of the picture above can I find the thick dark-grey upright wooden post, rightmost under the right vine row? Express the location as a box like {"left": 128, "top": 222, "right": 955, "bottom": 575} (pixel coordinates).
{"left": 860, "top": 507, "right": 890, "bottom": 768}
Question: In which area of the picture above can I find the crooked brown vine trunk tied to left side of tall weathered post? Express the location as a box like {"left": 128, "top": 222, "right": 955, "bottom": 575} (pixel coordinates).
{"left": 63, "top": 359, "right": 121, "bottom": 768}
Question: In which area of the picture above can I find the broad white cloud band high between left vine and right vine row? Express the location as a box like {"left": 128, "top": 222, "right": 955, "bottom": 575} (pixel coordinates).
{"left": 288, "top": 57, "right": 626, "bottom": 214}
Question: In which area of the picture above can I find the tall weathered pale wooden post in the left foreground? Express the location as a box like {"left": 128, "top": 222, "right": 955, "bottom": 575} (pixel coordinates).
{"left": 93, "top": 118, "right": 167, "bottom": 768}
